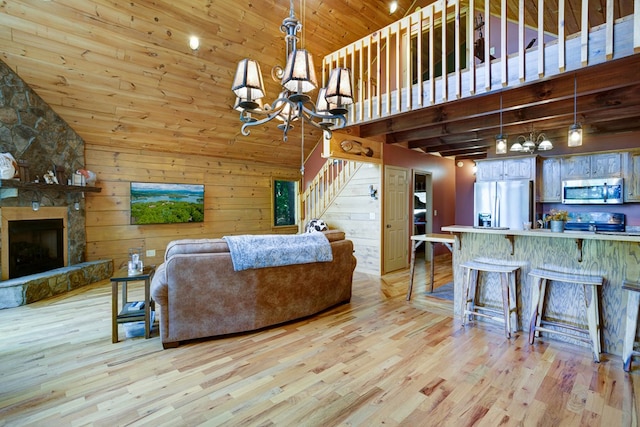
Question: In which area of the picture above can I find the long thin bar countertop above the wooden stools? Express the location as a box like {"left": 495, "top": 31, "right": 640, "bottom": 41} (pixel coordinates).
{"left": 441, "top": 225, "right": 640, "bottom": 243}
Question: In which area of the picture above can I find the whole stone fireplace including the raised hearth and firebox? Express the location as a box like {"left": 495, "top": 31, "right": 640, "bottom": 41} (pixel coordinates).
{"left": 0, "top": 61, "right": 113, "bottom": 309}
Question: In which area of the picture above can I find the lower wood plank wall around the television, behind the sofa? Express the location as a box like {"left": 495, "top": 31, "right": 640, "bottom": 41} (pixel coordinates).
{"left": 85, "top": 145, "right": 300, "bottom": 268}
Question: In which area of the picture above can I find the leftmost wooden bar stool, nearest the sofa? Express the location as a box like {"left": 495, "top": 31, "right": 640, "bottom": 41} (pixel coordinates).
{"left": 460, "top": 260, "right": 520, "bottom": 338}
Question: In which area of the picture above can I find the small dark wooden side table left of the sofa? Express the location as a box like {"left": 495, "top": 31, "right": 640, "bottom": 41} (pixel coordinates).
{"left": 111, "top": 265, "right": 156, "bottom": 343}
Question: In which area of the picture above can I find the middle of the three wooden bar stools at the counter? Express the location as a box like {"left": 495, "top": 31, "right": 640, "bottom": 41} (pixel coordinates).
{"left": 529, "top": 268, "right": 604, "bottom": 362}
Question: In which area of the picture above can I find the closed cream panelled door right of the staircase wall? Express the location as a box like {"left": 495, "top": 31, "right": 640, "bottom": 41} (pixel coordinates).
{"left": 383, "top": 166, "right": 409, "bottom": 273}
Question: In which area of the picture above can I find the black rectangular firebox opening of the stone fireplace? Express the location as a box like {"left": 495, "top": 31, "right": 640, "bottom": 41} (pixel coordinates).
{"left": 8, "top": 219, "right": 64, "bottom": 279}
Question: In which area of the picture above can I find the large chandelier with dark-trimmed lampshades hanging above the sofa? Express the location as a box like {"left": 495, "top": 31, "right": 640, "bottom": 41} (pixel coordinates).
{"left": 231, "top": 0, "right": 353, "bottom": 142}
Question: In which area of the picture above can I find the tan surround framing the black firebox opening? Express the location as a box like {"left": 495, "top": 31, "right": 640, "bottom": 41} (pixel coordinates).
{"left": 0, "top": 207, "right": 69, "bottom": 280}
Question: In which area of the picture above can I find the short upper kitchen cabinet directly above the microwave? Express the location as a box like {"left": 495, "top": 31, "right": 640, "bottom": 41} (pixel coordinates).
{"left": 561, "top": 153, "right": 623, "bottom": 180}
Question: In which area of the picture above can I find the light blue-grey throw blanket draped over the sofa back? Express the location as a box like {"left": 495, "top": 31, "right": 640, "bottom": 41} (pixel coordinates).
{"left": 224, "top": 233, "right": 333, "bottom": 271}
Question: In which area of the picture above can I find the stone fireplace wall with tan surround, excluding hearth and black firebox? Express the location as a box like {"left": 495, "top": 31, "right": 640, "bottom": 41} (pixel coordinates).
{"left": 0, "top": 61, "right": 86, "bottom": 280}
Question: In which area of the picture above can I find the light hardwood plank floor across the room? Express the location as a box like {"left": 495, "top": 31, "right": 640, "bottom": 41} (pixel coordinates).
{"left": 0, "top": 256, "right": 640, "bottom": 426}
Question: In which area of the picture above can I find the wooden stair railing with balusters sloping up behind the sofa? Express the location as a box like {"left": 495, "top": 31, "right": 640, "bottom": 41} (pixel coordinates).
{"left": 301, "top": 159, "right": 362, "bottom": 224}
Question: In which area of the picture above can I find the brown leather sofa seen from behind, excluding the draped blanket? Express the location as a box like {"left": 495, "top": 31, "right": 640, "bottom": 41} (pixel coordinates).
{"left": 151, "top": 230, "right": 356, "bottom": 348}
